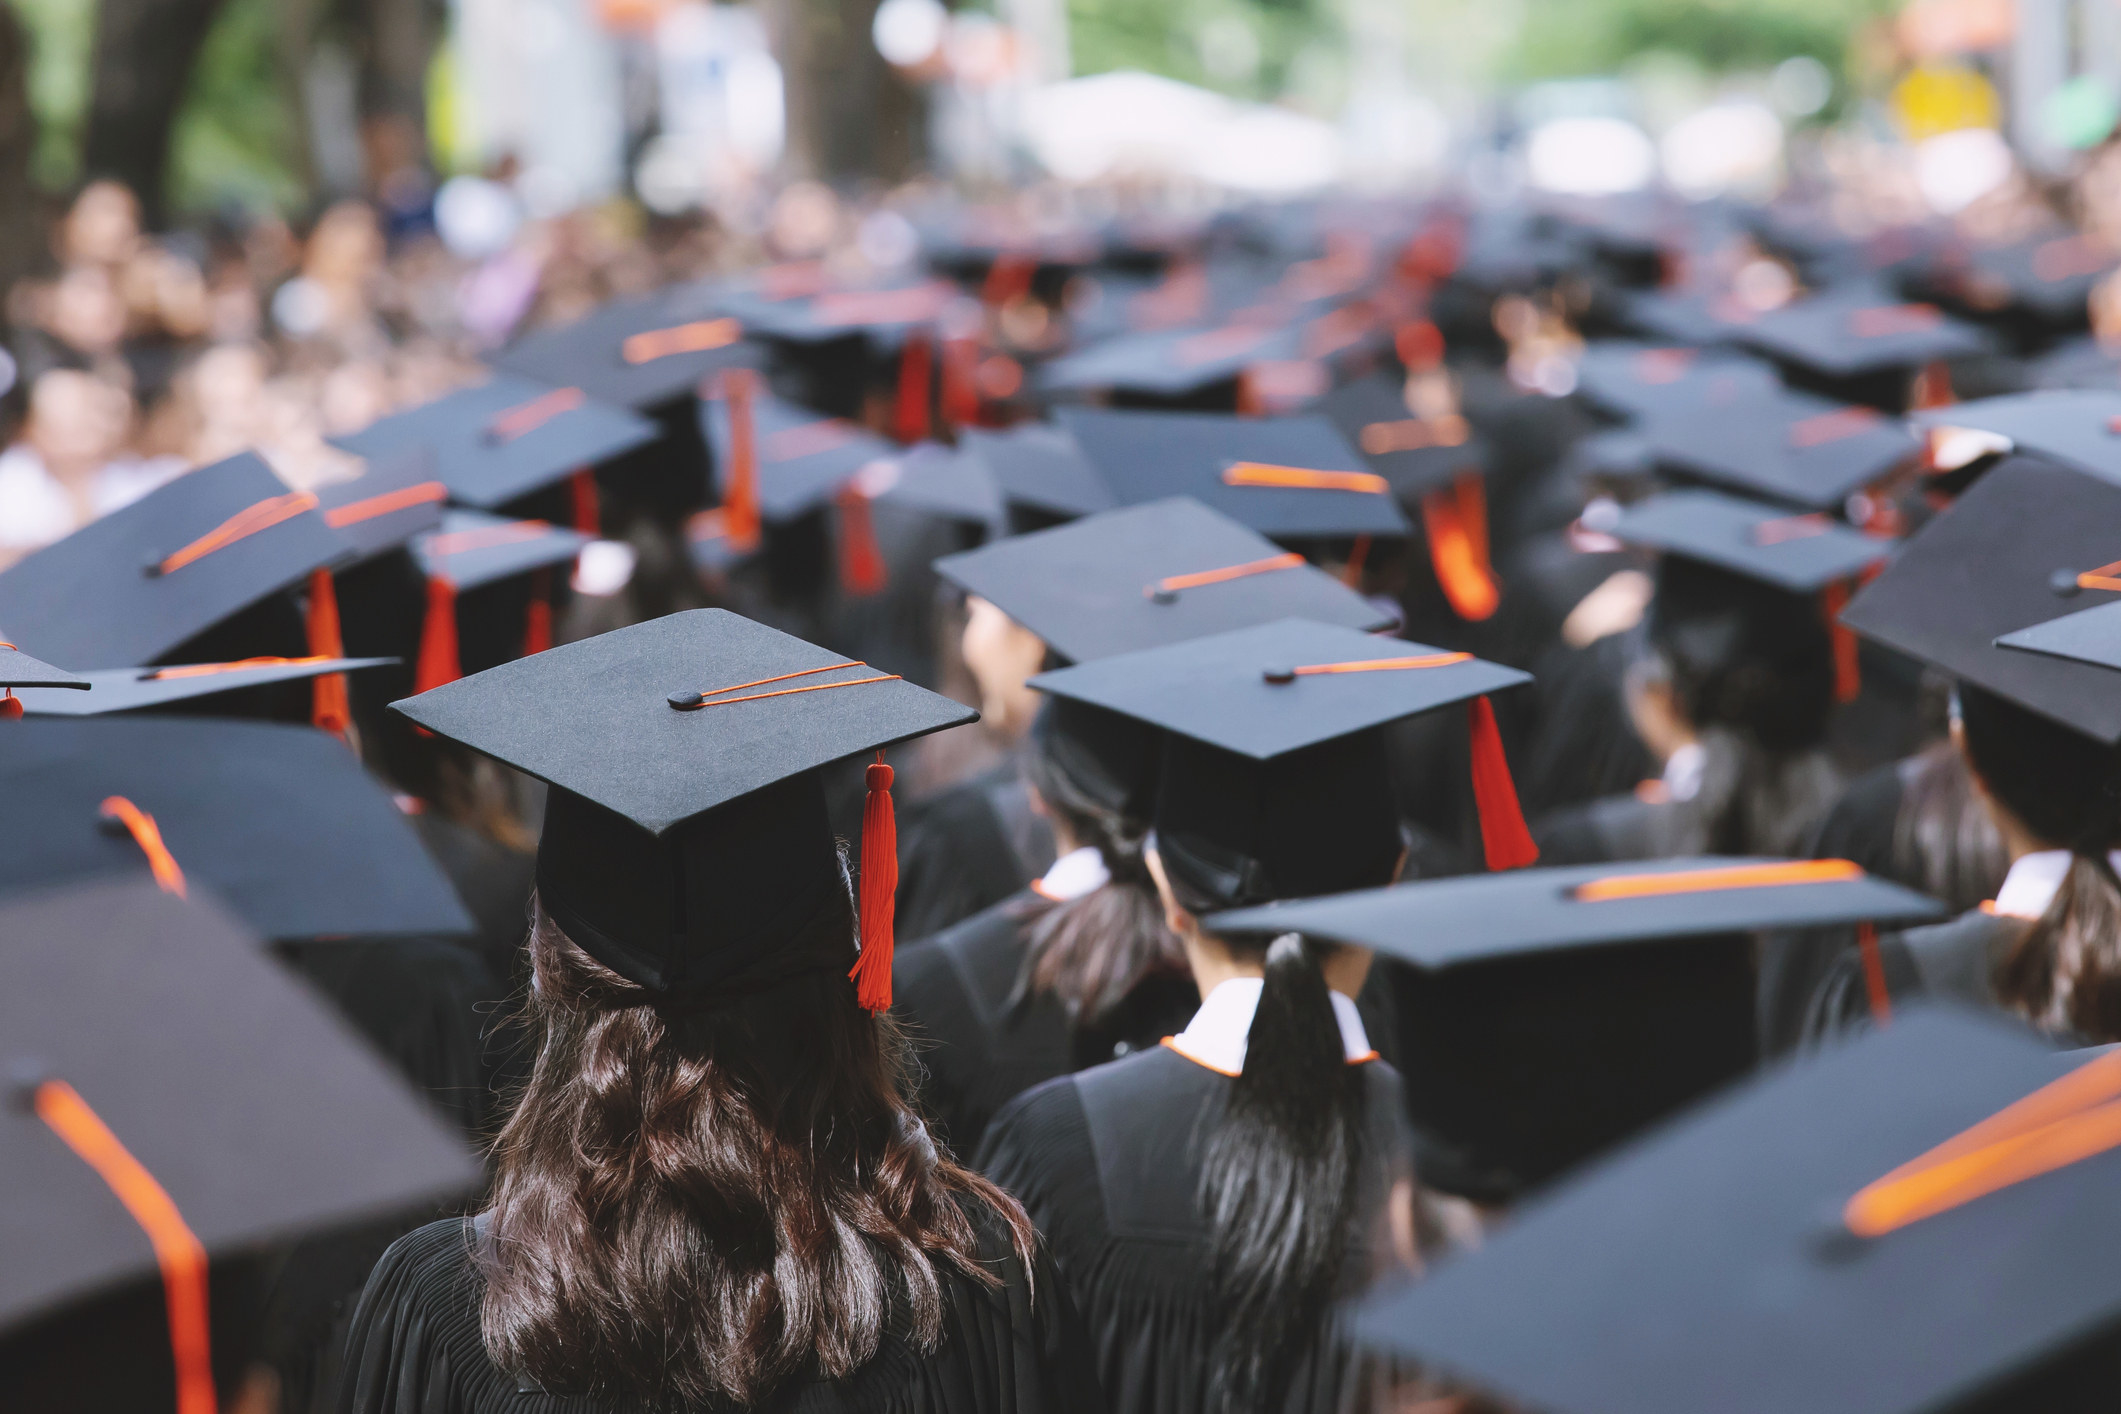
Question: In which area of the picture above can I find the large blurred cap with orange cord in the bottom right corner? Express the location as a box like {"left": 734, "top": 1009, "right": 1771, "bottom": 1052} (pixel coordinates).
{"left": 1355, "top": 1009, "right": 2121, "bottom": 1414}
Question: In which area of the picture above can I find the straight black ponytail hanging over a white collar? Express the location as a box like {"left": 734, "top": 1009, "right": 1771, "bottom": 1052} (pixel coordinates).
{"left": 1200, "top": 933, "right": 1364, "bottom": 1414}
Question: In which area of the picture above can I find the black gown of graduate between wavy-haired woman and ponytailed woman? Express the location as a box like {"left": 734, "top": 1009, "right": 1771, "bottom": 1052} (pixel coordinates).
{"left": 891, "top": 890, "right": 1200, "bottom": 1157}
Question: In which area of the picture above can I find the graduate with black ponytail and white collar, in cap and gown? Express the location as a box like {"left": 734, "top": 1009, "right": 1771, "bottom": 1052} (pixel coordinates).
{"left": 980, "top": 619, "right": 1529, "bottom": 1414}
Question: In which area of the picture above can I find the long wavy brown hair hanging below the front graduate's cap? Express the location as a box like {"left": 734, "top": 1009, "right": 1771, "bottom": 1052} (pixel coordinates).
{"left": 479, "top": 886, "right": 1033, "bottom": 1406}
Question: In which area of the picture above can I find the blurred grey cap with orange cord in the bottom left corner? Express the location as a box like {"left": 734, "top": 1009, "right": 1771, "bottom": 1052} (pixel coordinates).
{"left": 0, "top": 882, "right": 479, "bottom": 1410}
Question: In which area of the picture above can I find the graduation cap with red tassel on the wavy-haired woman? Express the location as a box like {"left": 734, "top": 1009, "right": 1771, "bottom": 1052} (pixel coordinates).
{"left": 392, "top": 608, "right": 978, "bottom": 1011}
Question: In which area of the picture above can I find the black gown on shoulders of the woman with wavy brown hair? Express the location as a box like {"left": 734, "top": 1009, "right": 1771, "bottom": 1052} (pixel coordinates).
{"left": 337, "top": 1215, "right": 1103, "bottom": 1414}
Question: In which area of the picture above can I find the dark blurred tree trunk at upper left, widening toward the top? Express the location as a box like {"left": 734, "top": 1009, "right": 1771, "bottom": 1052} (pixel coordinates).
{"left": 83, "top": 0, "right": 221, "bottom": 229}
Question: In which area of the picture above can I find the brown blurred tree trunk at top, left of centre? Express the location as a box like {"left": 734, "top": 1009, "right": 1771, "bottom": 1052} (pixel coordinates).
{"left": 768, "top": 0, "right": 927, "bottom": 182}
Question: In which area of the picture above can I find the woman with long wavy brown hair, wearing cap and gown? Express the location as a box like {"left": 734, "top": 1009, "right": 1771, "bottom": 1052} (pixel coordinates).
{"left": 339, "top": 611, "right": 1099, "bottom": 1414}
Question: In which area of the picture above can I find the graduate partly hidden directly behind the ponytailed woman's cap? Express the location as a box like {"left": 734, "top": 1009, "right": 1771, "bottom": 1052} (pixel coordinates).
{"left": 893, "top": 496, "right": 1385, "bottom": 1155}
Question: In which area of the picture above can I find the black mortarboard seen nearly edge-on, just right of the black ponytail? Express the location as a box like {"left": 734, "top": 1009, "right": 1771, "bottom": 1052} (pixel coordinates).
{"left": 1205, "top": 859, "right": 1943, "bottom": 1202}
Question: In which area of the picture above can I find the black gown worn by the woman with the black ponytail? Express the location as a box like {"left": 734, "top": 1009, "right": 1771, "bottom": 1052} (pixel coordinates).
{"left": 980, "top": 1045, "right": 1408, "bottom": 1414}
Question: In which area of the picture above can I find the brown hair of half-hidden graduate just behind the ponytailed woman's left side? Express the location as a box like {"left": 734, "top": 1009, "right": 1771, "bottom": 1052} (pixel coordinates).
{"left": 1016, "top": 731, "right": 1186, "bottom": 1024}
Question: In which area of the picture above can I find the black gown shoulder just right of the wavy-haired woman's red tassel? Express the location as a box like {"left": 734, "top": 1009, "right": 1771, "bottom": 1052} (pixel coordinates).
{"left": 893, "top": 757, "right": 1054, "bottom": 941}
